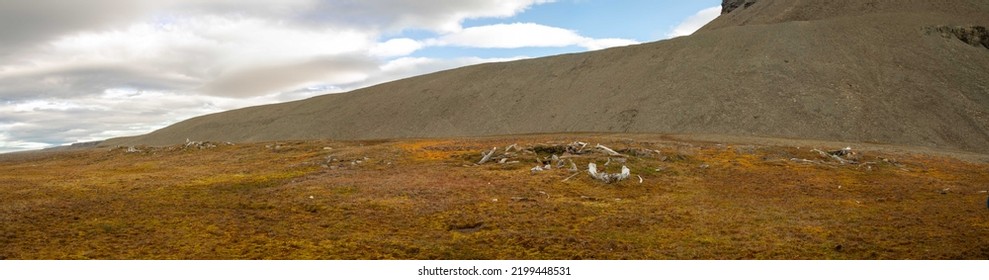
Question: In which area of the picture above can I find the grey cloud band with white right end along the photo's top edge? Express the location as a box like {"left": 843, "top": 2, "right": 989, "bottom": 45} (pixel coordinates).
{"left": 0, "top": 0, "right": 555, "bottom": 56}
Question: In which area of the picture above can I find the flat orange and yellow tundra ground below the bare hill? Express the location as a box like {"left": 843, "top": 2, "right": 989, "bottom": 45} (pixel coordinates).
{"left": 0, "top": 135, "right": 989, "bottom": 259}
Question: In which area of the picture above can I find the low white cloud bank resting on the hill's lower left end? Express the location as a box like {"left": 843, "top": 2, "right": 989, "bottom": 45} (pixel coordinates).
{"left": 0, "top": 89, "right": 300, "bottom": 153}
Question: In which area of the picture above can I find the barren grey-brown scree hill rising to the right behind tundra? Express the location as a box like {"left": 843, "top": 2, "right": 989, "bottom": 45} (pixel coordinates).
{"left": 105, "top": 0, "right": 989, "bottom": 152}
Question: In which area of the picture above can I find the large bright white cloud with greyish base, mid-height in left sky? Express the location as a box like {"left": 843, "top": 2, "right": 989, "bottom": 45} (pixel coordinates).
{"left": 0, "top": 16, "right": 375, "bottom": 98}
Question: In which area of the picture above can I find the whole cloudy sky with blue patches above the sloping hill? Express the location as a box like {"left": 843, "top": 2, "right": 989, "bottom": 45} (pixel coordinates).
{"left": 0, "top": 0, "right": 721, "bottom": 153}
